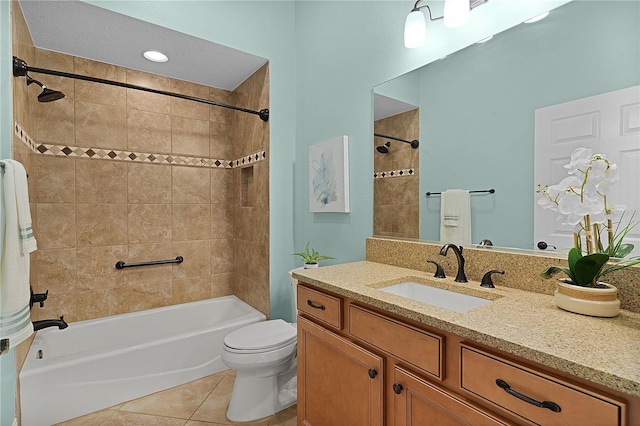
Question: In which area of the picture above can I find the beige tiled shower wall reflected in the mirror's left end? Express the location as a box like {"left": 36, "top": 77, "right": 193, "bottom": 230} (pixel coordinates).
{"left": 373, "top": 109, "right": 420, "bottom": 238}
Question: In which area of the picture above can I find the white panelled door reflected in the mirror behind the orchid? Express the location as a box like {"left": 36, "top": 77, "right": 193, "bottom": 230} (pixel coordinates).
{"left": 533, "top": 86, "right": 640, "bottom": 256}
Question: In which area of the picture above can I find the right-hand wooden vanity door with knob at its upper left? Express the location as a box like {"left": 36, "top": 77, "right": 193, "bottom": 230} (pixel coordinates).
{"left": 389, "top": 366, "right": 508, "bottom": 426}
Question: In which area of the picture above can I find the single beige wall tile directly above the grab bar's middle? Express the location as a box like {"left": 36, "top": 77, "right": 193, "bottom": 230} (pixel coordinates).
{"left": 127, "top": 204, "right": 172, "bottom": 244}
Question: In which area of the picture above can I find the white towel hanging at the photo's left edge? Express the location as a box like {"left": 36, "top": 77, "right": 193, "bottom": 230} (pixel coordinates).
{"left": 0, "top": 160, "right": 37, "bottom": 347}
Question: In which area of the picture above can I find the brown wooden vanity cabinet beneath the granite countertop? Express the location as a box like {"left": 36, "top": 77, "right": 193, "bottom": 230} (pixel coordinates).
{"left": 298, "top": 283, "right": 635, "bottom": 426}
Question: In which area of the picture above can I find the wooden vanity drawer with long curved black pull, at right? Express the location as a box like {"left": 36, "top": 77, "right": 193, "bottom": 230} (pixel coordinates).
{"left": 460, "top": 344, "right": 626, "bottom": 426}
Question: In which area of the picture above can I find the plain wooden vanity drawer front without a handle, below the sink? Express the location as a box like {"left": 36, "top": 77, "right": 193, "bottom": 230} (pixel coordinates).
{"left": 349, "top": 305, "right": 444, "bottom": 380}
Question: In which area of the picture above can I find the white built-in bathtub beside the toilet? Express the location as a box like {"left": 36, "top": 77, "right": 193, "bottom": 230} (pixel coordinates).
{"left": 20, "top": 296, "right": 265, "bottom": 426}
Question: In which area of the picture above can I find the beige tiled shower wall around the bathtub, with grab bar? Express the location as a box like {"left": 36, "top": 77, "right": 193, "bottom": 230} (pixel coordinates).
{"left": 19, "top": 49, "right": 269, "bottom": 321}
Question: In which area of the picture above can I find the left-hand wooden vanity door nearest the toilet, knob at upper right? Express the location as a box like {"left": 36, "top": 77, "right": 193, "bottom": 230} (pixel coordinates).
{"left": 298, "top": 317, "right": 384, "bottom": 426}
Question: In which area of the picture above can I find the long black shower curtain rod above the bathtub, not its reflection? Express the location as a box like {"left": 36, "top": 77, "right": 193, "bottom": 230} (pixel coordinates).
{"left": 13, "top": 56, "right": 269, "bottom": 121}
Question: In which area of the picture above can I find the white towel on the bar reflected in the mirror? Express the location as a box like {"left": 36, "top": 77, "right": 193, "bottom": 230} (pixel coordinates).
{"left": 440, "top": 189, "right": 471, "bottom": 245}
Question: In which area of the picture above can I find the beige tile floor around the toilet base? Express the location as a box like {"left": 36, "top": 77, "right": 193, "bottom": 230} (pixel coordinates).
{"left": 55, "top": 370, "right": 297, "bottom": 426}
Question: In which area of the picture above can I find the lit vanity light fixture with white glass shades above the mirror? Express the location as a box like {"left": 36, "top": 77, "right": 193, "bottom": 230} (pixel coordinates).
{"left": 404, "top": 0, "right": 489, "bottom": 49}
